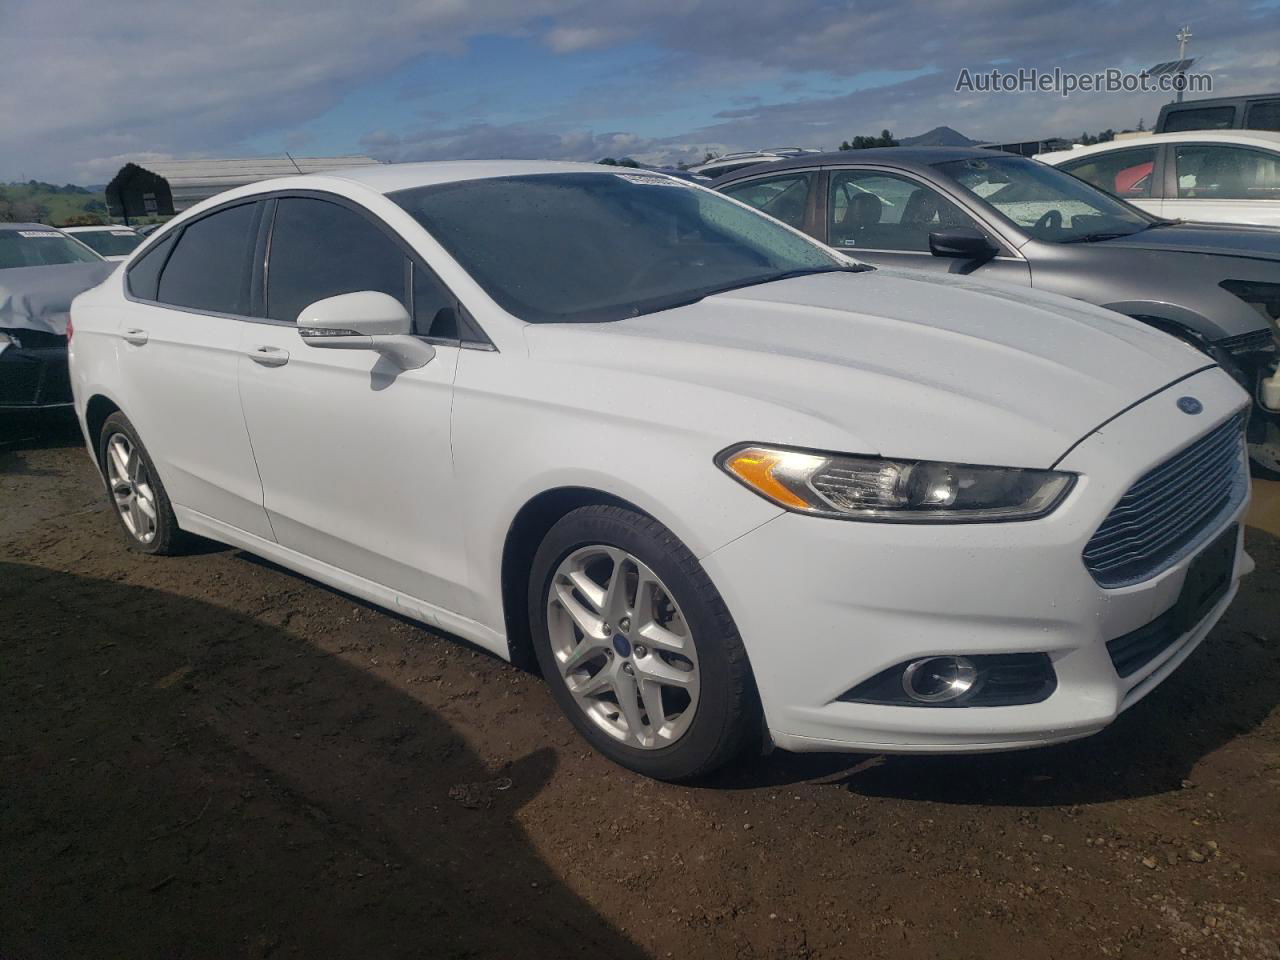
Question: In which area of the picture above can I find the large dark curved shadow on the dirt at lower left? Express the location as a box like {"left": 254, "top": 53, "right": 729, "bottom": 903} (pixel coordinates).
{"left": 0, "top": 563, "right": 643, "bottom": 960}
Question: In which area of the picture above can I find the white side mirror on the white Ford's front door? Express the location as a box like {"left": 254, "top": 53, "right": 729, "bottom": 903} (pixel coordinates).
{"left": 298, "top": 291, "right": 435, "bottom": 370}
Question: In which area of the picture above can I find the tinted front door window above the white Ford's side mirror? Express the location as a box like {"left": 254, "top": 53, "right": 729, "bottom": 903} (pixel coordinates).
{"left": 266, "top": 197, "right": 408, "bottom": 324}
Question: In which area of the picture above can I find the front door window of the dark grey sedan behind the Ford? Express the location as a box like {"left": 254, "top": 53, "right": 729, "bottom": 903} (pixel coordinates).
{"left": 827, "top": 170, "right": 982, "bottom": 253}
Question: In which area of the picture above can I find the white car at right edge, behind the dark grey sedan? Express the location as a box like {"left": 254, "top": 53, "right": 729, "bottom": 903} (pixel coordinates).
{"left": 1036, "top": 131, "right": 1280, "bottom": 229}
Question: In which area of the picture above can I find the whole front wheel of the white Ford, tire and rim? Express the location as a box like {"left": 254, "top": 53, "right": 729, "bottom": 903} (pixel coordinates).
{"left": 529, "top": 506, "right": 760, "bottom": 781}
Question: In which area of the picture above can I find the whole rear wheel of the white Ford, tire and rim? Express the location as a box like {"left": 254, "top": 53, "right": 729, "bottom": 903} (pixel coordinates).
{"left": 99, "top": 412, "right": 186, "bottom": 556}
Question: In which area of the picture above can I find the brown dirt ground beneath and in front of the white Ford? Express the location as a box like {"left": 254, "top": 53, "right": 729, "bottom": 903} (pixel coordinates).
{"left": 0, "top": 414, "right": 1280, "bottom": 960}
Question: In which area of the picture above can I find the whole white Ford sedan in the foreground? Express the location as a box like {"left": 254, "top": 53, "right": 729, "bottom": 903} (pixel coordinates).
{"left": 69, "top": 161, "right": 1251, "bottom": 780}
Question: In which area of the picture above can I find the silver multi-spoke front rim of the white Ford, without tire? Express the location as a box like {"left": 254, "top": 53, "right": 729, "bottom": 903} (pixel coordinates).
{"left": 547, "top": 544, "right": 700, "bottom": 750}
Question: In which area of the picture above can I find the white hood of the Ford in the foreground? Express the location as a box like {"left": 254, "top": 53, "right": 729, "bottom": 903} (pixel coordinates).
{"left": 526, "top": 269, "right": 1212, "bottom": 467}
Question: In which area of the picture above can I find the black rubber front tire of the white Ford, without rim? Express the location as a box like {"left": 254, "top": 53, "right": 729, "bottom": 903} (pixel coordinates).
{"left": 529, "top": 504, "right": 762, "bottom": 781}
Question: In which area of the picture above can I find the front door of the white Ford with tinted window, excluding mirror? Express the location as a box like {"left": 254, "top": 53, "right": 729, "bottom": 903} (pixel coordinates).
{"left": 239, "top": 195, "right": 463, "bottom": 609}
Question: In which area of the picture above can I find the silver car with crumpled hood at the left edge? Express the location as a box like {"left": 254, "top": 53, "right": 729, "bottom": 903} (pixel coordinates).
{"left": 0, "top": 223, "right": 114, "bottom": 413}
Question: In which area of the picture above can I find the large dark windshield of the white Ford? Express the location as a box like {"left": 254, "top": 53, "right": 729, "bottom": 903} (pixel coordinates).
{"left": 390, "top": 173, "right": 863, "bottom": 323}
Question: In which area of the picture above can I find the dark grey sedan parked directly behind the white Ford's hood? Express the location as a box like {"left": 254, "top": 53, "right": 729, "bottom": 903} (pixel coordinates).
{"left": 716, "top": 147, "right": 1280, "bottom": 471}
